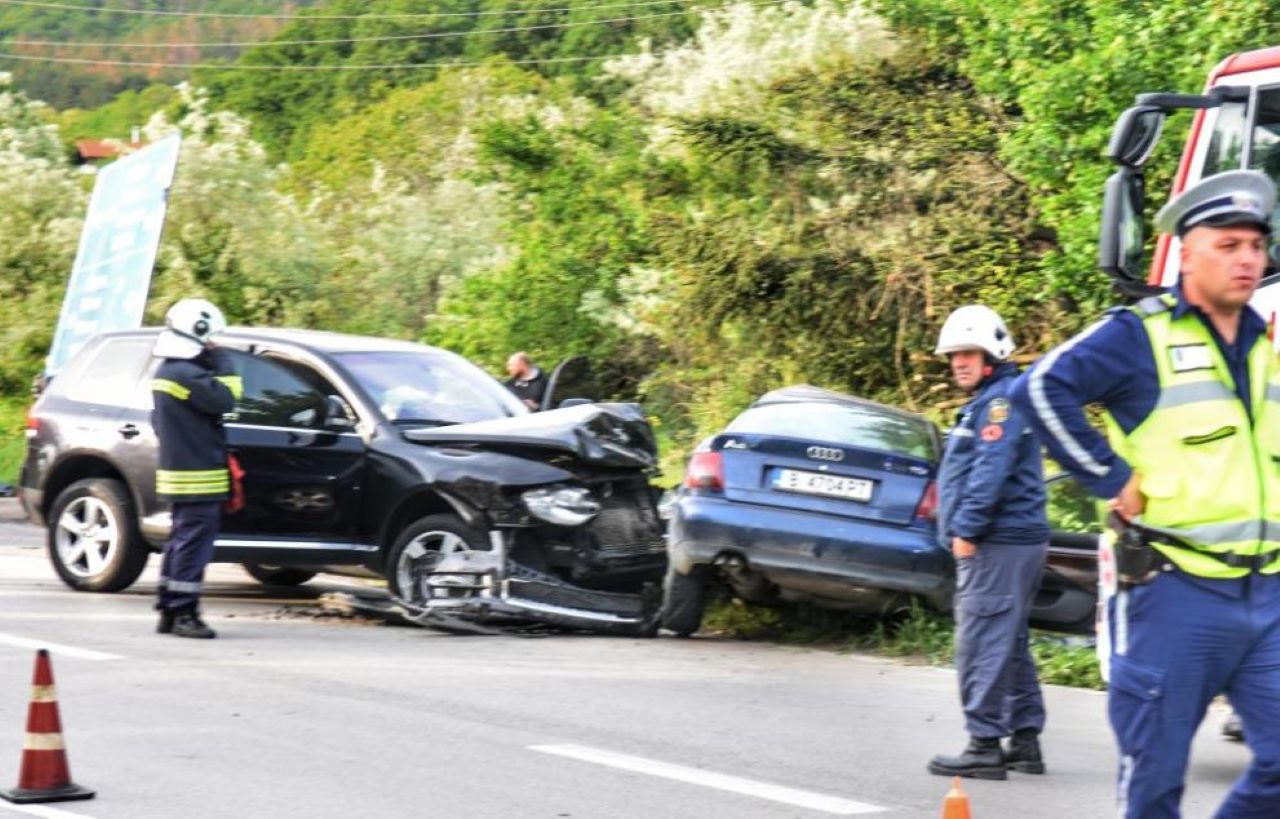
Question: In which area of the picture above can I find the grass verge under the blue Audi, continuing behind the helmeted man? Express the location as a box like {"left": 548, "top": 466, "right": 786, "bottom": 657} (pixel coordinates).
{"left": 703, "top": 599, "right": 1103, "bottom": 690}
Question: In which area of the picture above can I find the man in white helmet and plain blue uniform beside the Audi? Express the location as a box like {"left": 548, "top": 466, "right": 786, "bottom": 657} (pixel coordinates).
{"left": 929, "top": 305, "right": 1048, "bottom": 779}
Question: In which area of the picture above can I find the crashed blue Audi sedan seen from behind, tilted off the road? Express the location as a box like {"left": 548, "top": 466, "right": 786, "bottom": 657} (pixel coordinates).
{"left": 662, "top": 385, "right": 1096, "bottom": 636}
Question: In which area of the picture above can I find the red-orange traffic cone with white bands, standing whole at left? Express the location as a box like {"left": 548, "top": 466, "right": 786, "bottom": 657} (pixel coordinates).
{"left": 0, "top": 649, "right": 93, "bottom": 804}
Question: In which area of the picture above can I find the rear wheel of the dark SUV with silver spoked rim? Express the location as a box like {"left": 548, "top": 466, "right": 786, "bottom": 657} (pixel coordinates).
{"left": 46, "top": 477, "right": 151, "bottom": 591}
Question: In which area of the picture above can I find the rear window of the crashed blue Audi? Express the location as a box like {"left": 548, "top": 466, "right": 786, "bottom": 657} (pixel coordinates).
{"left": 724, "top": 402, "right": 937, "bottom": 461}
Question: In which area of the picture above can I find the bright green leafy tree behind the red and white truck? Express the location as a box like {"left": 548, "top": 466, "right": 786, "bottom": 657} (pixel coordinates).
{"left": 874, "top": 0, "right": 1280, "bottom": 319}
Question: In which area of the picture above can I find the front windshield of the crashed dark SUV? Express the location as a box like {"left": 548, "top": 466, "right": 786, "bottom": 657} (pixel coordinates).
{"left": 334, "top": 351, "right": 529, "bottom": 425}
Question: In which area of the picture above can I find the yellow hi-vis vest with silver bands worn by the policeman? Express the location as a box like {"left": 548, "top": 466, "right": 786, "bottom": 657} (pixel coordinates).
{"left": 1106, "top": 294, "right": 1280, "bottom": 577}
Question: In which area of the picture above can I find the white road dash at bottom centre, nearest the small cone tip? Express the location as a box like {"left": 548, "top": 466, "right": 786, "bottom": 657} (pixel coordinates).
{"left": 529, "top": 745, "right": 888, "bottom": 816}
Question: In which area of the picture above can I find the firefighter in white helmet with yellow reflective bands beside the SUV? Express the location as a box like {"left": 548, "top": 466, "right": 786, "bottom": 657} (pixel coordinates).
{"left": 151, "top": 298, "right": 243, "bottom": 639}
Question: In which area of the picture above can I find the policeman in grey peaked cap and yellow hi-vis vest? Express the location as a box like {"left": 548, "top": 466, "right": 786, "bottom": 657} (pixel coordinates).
{"left": 1014, "top": 171, "right": 1280, "bottom": 819}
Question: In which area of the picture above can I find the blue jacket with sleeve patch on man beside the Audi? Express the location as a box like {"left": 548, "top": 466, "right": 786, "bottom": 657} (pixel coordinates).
{"left": 938, "top": 363, "right": 1048, "bottom": 548}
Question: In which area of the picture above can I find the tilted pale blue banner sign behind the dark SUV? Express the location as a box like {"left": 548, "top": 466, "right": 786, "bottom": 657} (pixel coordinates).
{"left": 45, "top": 134, "right": 182, "bottom": 375}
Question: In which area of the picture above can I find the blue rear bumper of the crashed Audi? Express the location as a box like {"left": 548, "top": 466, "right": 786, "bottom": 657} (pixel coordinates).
{"left": 668, "top": 495, "right": 955, "bottom": 609}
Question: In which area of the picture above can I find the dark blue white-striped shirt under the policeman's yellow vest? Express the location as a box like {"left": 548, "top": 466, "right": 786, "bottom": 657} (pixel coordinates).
{"left": 1011, "top": 287, "right": 1267, "bottom": 498}
